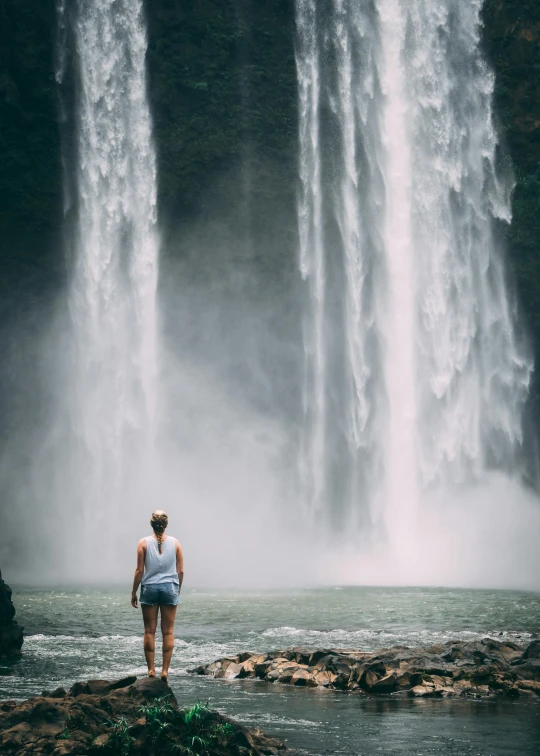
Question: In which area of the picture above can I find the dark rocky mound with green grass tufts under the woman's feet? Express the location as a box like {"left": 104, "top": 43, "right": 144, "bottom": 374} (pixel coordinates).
{"left": 0, "top": 677, "right": 285, "bottom": 756}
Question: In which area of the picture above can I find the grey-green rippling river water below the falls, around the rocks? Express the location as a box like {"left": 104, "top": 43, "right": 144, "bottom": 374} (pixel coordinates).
{"left": 0, "top": 586, "right": 540, "bottom": 756}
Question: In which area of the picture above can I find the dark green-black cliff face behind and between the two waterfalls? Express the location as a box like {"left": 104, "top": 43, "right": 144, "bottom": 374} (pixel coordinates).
{"left": 0, "top": 0, "right": 540, "bottom": 402}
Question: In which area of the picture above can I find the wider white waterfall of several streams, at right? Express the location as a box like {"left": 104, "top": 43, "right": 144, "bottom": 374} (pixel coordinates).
{"left": 296, "top": 0, "right": 532, "bottom": 541}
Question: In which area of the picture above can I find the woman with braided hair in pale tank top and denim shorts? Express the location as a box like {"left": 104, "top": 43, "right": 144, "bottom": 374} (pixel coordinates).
{"left": 131, "top": 509, "right": 184, "bottom": 683}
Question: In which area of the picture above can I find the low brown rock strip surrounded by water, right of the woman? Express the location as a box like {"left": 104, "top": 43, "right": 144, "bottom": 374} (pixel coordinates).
{"left": 189, "top": 638, "right": 540, "bottom": 698}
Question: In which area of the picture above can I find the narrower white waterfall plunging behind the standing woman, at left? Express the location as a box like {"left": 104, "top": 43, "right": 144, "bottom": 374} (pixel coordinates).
{"left": 59, "top": 0, "right": 159, "bottom": 544}
